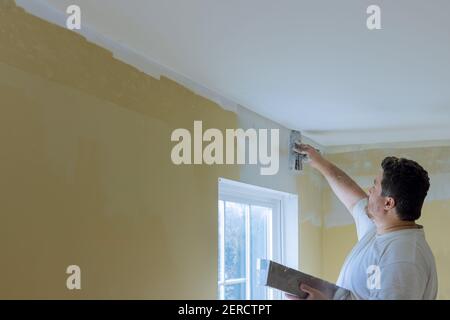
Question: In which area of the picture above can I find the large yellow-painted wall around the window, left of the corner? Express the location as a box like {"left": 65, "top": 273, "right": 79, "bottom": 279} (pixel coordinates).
{"left": 0, "top": 0, "right": 321, "bottom": 299}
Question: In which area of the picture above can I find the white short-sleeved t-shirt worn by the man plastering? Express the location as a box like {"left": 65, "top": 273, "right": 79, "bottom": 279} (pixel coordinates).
{"left": 337, "top": 199, "right": 438, "bottom": 300}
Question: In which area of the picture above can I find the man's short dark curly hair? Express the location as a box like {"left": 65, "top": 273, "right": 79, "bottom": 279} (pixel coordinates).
{"left": 381, "top": 157, "right": 430, "bottom": 221}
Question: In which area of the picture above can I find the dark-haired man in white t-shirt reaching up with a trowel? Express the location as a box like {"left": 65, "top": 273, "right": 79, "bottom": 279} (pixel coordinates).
{"left": 288, "top": 144, "right": 438, "bottom": 300}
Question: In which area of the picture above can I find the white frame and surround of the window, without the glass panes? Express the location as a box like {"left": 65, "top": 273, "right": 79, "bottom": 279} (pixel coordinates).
{"left": 218, "top": 178, "right": 298, "bottom": 300}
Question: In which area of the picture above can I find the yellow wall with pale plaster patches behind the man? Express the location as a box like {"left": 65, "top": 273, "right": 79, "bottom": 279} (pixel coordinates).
{"left": 322, "top": 147, "right": 450, "bottom": 299}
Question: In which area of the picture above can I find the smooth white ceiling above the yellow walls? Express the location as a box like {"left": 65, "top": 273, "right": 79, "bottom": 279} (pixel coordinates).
{"left": 17, "top": 0, "right": 450, "bottom": 146}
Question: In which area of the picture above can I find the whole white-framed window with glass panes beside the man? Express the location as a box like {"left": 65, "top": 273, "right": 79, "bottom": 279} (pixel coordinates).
{"left": 218, "top": 179, "right": 298, "bottom": 300}
